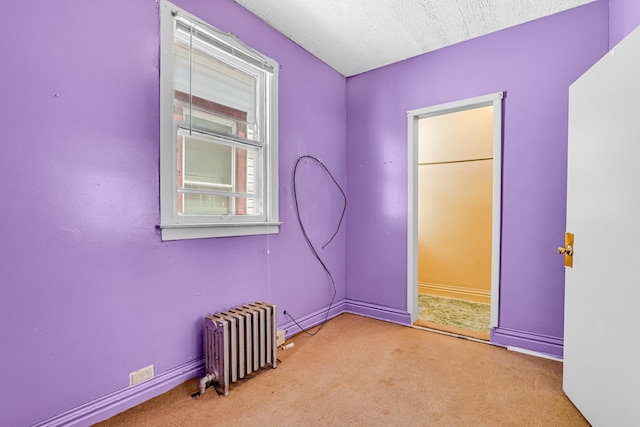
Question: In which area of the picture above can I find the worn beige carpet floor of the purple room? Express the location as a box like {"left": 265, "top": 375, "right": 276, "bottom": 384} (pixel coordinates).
{"left": 94, "top": 314, "right": 588, "bottom": 427}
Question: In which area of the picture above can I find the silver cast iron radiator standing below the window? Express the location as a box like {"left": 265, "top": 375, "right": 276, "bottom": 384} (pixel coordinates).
{"left": 200, "top": 302, "right": 277, "bottom": 396}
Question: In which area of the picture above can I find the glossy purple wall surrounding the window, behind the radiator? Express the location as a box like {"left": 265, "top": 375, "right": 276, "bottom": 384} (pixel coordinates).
{"left": 0, "top": 0, "right": 346, "bottom": 426}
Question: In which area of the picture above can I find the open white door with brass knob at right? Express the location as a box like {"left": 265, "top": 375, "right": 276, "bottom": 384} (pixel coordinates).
{"left": 563, "top": 29, "right": 640, "bottom": 426}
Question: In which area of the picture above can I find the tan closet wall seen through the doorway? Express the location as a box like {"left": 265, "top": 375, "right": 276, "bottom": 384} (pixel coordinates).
{"left": 418, "top": 107, "right": 493, "bottom": 303}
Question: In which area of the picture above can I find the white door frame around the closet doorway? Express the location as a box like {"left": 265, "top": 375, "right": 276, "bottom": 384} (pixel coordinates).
{"left": 407, "top": 92, "right": 504, "bottom": 328}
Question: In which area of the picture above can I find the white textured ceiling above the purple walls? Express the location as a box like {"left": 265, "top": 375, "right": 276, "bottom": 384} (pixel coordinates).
{"left": 235, "top": 0, "right": 595, "bottom": 76}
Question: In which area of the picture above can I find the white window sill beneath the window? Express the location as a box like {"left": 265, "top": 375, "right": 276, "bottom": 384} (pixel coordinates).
{"left": 160, "top": 222, "right": 281, "bottom": 241}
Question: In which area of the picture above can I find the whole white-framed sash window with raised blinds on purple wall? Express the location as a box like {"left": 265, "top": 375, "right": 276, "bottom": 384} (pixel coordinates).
{"left": 160, "top": 1, "right": 279, "bottom": 240}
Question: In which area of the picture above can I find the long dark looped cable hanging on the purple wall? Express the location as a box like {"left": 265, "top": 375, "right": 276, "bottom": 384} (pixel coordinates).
{"left": 284, "top": 154, "right": 347, "bottom": 336}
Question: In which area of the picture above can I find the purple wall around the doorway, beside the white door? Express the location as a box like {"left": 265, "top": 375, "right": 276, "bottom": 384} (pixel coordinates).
{"left": 347, "top": 1, "right": 608, "bottom": 354}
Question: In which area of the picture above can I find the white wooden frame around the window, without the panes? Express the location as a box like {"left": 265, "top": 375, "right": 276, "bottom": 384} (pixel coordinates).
{"left": 160, "top": 0, "right": 280, "bottom": 240}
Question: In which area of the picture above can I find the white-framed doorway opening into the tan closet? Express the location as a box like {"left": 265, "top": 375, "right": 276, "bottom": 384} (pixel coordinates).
{"left": 407, "top": 92, "right": 503, "bottom": 340}
